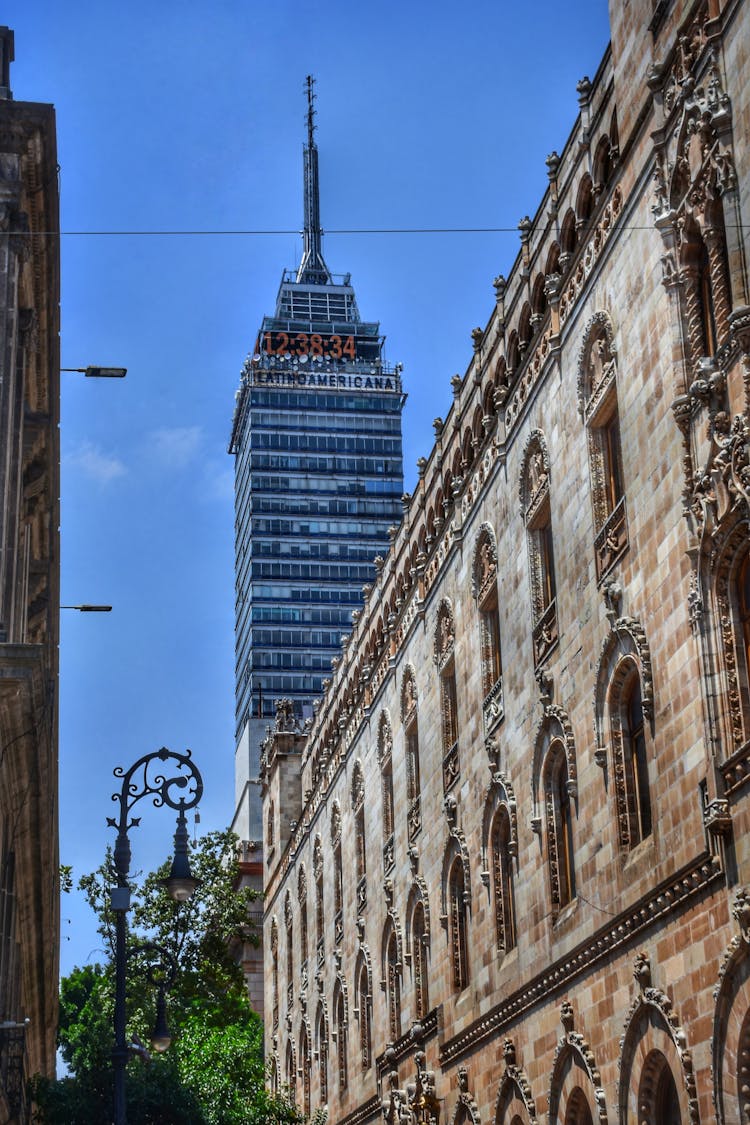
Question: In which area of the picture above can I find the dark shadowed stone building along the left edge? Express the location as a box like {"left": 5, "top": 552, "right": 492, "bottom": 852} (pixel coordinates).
{"left": 0, "top": 27, "right": 60, "bottom": 1123}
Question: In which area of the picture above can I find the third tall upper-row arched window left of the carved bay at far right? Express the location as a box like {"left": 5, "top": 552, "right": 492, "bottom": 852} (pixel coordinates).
{"left": 472, "top": 523, "right": 504, "bottom": 737}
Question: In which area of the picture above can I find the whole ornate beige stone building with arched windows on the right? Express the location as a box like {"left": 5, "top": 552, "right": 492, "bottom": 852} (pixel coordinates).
{"left": 262, "top": 0, "right": 750, "bottom": 1125}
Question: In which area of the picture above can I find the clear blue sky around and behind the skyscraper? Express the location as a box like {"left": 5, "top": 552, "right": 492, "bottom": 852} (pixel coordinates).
{"left": 7, "top": 0, "right": 608, "bottom": 972}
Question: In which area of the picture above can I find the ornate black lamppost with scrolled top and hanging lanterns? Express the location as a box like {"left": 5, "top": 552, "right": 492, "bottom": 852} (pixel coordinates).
{"left": 107, "top": 747, "right": 204, "bottom": 1125}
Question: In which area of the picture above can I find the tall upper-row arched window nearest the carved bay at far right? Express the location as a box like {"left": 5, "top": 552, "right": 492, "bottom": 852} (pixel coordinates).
{"left": 578, "top": 313, "right": 627, "bottom": 582}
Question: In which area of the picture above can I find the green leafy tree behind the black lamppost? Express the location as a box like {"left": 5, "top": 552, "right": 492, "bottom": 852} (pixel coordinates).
{"left": 34, "top": 833, "right": 302, "bottom": 1125}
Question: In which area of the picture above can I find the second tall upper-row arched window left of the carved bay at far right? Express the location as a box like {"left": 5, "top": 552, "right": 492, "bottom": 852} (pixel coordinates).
{"left": 521, "top": 430, "right": 558, "bottom": 667}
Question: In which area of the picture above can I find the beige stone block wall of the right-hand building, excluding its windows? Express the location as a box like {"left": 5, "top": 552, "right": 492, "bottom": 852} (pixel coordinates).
{"left": 262, "top": 2, "right": 750, "bottom": 1125}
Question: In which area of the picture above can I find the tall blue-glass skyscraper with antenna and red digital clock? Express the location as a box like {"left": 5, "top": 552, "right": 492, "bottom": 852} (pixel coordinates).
{"left": 229, "top": 78, "right": 404, "bottom": 967}
